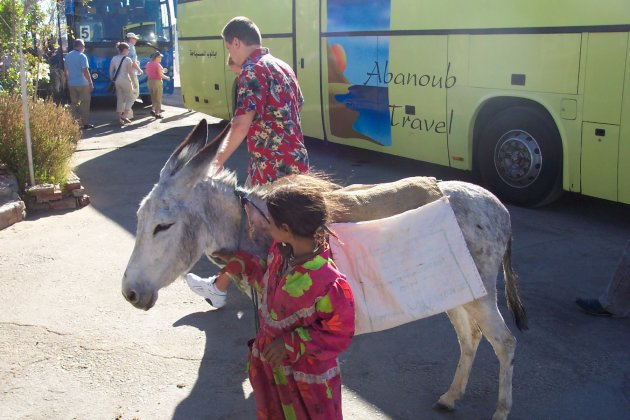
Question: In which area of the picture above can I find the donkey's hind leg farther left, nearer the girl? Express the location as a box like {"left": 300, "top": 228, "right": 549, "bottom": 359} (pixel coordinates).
{"left": 433, "top": 306, "right": 481, "bottom": 411}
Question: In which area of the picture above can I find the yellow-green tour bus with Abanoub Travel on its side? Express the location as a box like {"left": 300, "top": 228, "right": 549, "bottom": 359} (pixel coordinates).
{"left": 178, "top": 0, "right": 630, "bottom": 206}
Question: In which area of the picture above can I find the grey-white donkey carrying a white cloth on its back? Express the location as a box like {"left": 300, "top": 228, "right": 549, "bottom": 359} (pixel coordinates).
{"left": 122, "top": 120, "right": 527, "bottom": 419}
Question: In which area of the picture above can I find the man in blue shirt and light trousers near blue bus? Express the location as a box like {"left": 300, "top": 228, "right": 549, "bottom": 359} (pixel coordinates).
{"left": 64, "top": 39, "right": 94, "bottom": 129}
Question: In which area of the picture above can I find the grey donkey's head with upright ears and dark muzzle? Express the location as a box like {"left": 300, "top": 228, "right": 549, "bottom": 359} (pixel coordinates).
{"left": 122, "top": 120, "right": 235, "bottom": 310}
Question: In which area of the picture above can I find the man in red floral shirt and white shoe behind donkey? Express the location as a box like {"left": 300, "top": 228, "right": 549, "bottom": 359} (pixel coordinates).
{"left": 186, "top": 16, "right": 309, "bottom": 308}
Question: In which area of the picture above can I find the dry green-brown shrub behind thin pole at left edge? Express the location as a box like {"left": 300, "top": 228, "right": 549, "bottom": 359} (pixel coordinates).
{"left": 0, "top": 93, "right": 81, "bottom": 188}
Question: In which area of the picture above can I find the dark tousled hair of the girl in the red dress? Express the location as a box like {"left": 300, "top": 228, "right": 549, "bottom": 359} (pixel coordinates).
{"left": 265, "top": 174, "right": 344, "bottom": 237}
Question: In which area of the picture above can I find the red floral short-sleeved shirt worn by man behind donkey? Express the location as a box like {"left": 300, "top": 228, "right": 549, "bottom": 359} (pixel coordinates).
{"left": 234, "top": 48, "right": 308, "bottom": 185}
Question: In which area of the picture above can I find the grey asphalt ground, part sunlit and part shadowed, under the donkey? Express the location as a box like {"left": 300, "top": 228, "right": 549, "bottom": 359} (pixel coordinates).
{"left": 0, "top": 98, "right": 630, "bottom": 420}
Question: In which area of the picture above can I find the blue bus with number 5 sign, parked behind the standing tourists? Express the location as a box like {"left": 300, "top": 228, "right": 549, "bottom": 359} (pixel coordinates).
{"left": 65, "top": 0, "right": 175, "bottom": 102}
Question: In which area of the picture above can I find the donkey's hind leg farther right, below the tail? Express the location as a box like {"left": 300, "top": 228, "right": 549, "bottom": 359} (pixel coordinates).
{"left": 464, "top": 296, "right": 516, "bottom": 420}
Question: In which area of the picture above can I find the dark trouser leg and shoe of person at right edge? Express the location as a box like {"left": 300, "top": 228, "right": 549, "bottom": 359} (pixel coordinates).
{"left": 575, "top": 241, "right": 630, "bottom": 318}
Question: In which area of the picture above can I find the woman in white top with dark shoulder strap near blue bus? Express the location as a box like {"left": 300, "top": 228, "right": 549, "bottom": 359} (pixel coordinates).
{"left": 109, "top": 42, "right": 136, "bottom": 125}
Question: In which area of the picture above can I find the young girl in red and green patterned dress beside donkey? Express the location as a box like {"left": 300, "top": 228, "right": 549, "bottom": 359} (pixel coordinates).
{"left": 216, "top": 175, "right": 354, "bottom": 420}
